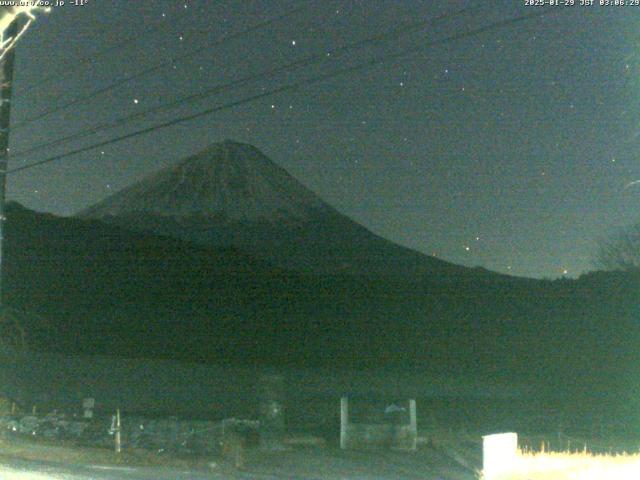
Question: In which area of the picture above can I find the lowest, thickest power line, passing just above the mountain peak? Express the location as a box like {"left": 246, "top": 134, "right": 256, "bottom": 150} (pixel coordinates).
{"left": 7, "top": 8, "right": 556, "bottom": 174}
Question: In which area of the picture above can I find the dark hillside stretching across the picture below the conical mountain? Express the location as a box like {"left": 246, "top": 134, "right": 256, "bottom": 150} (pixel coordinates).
{"left": 5, "top": 205, "right": 640, "bottom": 414}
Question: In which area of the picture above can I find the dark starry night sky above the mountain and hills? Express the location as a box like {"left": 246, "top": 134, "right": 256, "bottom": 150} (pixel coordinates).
{"left": 2, "top": 0, "right": 640, "bottom": 278}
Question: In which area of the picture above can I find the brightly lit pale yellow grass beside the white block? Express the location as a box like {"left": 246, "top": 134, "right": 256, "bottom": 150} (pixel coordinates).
{"left": 486, "top": 452, "right": 640, "bottom": 480}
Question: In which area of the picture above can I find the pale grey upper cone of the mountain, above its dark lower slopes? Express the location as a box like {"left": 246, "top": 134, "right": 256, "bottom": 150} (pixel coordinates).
{"left": 81, "top": 140, "right": 326, "bottom": 223}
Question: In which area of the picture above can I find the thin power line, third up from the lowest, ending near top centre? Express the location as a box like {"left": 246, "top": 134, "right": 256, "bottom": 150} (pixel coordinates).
{"left": 12, "top": 3, "right": 306, "bottom": 130}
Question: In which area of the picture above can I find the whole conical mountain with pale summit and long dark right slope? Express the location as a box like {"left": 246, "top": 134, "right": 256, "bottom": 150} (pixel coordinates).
{"left": 79, "top": 141, "right": 480, "bottom": 277}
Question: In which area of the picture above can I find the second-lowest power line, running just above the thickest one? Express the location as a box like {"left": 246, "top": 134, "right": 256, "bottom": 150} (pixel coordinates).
{"left": 12, "top": 3, "right": 478, "bottom": 158}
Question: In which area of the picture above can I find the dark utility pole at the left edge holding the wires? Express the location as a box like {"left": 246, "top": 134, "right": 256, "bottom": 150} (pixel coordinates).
{"left": 0, "top": 20, "right": 18, "bottom": 308}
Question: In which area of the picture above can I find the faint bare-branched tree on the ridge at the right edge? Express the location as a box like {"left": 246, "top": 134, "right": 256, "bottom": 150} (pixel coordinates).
{"left": 595, "top": 222, "right": 640, "bottom": 271}
